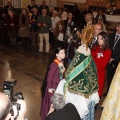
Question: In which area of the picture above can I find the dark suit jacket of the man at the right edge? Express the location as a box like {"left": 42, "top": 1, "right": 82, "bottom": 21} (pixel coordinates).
{"left": 109, "top": 33, "right": 120, "bottom": 62}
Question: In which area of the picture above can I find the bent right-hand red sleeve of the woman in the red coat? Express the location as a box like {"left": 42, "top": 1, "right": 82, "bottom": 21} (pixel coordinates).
{"left": 96, "top": 50, "right": 111, "bottom": 71}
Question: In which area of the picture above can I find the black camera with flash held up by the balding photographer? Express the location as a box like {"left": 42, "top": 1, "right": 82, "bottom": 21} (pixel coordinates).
{"left": 3, "top": 79, "right": 24, "bottom": 120}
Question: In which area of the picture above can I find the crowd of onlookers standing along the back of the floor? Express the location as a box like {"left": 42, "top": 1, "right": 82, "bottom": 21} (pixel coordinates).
{"left": 0, "top": 0, "right": 106, "bottom": 50}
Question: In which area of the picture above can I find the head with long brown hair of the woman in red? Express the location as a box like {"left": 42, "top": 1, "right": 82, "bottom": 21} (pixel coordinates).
{"left": 98, "top": 32, "right": 108, "bottom": 50}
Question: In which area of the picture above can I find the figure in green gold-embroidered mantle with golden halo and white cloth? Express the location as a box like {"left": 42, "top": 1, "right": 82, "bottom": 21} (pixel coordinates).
{"left": 56, "top": 25, "right": 99, "bottom": 120}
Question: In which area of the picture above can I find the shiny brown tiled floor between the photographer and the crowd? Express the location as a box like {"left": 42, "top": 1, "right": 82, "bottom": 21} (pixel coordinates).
{"left": 0, "top": 45, "right": 107, "bottom": 120}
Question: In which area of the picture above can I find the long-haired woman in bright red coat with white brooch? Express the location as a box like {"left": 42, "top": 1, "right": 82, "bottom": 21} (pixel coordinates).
{"left": 91, "top": 32, "right": 111, "bottom": 97}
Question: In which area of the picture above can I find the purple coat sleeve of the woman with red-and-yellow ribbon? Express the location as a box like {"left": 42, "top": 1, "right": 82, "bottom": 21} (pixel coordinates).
{"left": 47, "top": 62, "right": 58, "bottom": 88}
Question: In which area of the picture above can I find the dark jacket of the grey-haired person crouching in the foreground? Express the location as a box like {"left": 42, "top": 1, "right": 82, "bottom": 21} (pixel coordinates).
{"left": 46, "top": 103, "right": 81, "bottom": 120}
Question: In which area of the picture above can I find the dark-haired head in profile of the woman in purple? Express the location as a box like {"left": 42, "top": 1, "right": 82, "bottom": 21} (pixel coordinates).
{"left": 55, "top": 46, "right": 65, "bottom": 60}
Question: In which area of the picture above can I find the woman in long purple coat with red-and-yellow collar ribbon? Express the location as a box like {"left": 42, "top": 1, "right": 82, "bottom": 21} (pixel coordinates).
{"left": 40, "top": 46, "right": 65, "bottom": 120}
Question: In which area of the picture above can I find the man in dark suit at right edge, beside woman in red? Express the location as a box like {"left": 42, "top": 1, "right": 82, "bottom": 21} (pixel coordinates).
{"left": 107, "top": 22, "right": 120, "bottom": 93}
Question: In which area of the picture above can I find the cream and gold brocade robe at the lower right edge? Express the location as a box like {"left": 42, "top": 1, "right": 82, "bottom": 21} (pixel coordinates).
{"left": 100, "top": 63, "right": 120, "bottom": 120}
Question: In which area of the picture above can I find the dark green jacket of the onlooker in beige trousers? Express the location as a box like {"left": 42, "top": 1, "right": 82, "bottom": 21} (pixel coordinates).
{"left": 37, "top": 15, "right": 52, "bottom": 33}
